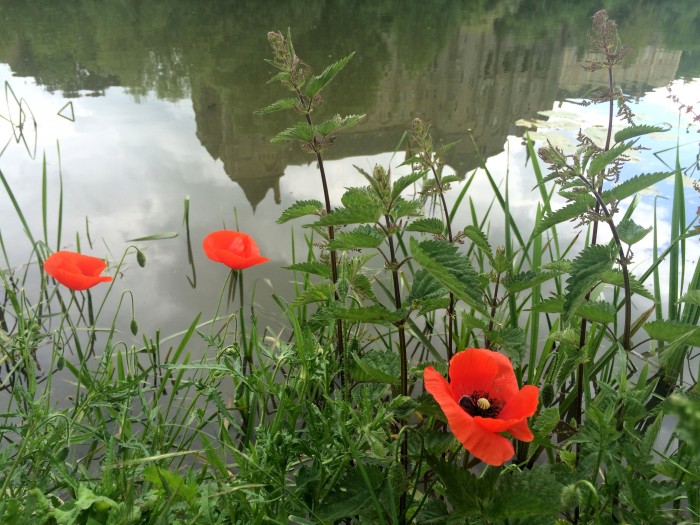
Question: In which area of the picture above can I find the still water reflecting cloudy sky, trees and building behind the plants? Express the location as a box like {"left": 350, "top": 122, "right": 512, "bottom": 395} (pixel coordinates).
{"left": 0, "top": 0, "right": 700, "bottom": 358}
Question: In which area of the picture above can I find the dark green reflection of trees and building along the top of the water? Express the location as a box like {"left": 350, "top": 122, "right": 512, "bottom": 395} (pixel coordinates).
{"left": 0, "top": 0, "right": 700, "bottom": 206}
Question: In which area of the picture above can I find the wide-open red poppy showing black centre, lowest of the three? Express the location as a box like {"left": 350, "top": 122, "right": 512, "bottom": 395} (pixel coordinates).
{"left": 423, "top": 348, "right": 539, "bottom": 466}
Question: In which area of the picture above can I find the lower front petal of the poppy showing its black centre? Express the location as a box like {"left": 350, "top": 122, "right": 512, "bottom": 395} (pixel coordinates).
{"left": 423, "top": 366, "right": 515, "bottom": 466}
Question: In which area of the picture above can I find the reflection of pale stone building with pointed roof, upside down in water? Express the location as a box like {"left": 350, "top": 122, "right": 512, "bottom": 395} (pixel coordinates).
{"left": 192, "top": 22, "right": 680, "bottom": 208}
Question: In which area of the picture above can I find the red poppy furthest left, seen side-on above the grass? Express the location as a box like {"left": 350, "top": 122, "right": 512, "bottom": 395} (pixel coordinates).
{"left": 44, "top": 251, "right": 112, "bottom": 290}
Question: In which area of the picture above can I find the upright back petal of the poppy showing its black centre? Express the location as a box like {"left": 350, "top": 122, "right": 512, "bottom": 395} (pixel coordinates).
{"left": 450, "top": 348, "right": 518, "bottom": 402}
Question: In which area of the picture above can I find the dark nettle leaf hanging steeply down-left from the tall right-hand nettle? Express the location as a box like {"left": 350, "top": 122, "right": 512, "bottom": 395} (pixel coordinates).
{"left": 564, "top": 244, "right": 614, "bottom": 320}
